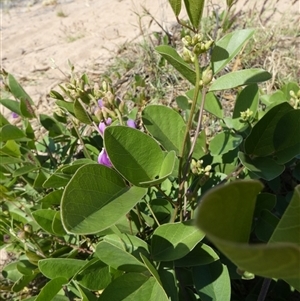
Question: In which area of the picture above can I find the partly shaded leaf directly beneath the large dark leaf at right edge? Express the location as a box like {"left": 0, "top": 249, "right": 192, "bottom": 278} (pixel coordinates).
{"left": 238, "top": 152, "right": 284, "bottom": 181}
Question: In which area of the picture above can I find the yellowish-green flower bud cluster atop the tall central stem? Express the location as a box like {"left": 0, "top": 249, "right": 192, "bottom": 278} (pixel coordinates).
{"left": 182, "top": 33, "right": 214, "bottom": 63}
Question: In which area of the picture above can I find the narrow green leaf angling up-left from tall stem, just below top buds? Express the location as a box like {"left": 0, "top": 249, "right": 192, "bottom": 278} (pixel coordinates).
{"left": 155, "top": 45, "right": 196, "bottom": 85}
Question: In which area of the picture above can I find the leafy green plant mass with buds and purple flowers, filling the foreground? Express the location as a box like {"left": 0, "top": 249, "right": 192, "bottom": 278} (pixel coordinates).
{"left": 0, "top": 0, "right": 300, "bottom": 301}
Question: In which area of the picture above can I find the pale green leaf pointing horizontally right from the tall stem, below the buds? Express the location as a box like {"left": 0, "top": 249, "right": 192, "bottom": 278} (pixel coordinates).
{"left": 209, "top": 68, "right": 272, "bottom": 91}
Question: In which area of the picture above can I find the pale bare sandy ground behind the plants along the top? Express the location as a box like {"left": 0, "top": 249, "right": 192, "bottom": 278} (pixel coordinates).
{"left": 0, "top": 0, "right": 300, "bottom": 118}
